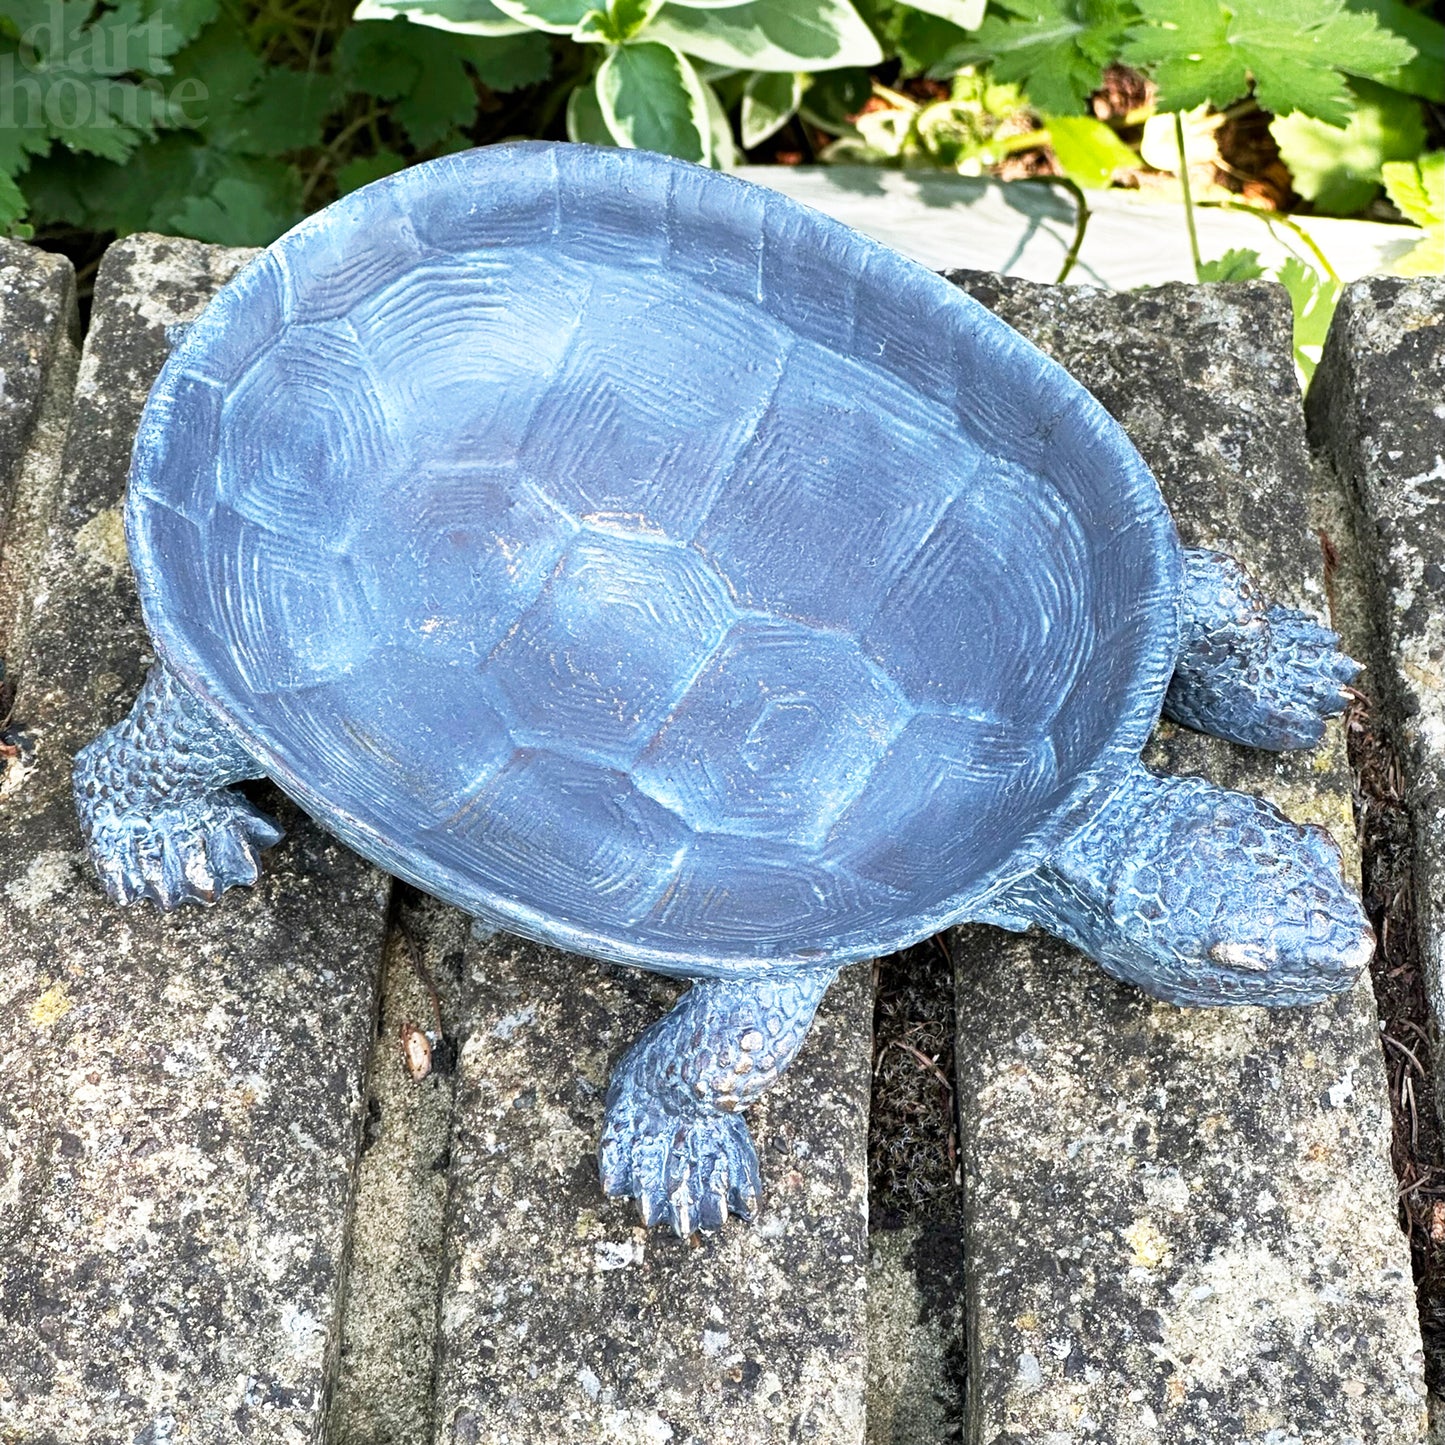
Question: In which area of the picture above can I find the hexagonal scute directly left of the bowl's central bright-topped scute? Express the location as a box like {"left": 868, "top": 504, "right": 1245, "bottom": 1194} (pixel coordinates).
{"left": 351, "top": 462, "right": 577, "bottom": 666}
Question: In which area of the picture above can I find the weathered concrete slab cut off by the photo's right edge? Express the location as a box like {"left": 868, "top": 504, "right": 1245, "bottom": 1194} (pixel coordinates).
{"left": 1308, "top": 276, "right": 1445, "bottom": 1075}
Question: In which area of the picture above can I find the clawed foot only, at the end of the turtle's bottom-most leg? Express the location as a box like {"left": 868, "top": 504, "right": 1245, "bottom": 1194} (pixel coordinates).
{"left": 598, "top": 1071, "right": 762, "bottom": 1238}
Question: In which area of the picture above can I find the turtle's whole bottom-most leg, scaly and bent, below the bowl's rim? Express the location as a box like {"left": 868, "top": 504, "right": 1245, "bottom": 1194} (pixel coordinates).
{"left": 598, "top": 964, "right": 837, "bottom": 1237}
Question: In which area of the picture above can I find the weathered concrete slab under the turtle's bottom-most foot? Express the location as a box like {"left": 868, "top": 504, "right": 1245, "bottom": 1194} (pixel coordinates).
{"left": 435, "top": 935, "right": 871, "bottom": 1445}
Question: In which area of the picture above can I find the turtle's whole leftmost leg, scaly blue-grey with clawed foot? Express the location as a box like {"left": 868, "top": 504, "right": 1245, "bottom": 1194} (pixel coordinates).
{"left": 74, "top": 663, "right": 282, "bottom": 909}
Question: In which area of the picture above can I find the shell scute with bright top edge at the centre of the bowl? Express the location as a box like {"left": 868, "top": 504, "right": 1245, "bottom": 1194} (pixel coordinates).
{"left": 487, "top": 527, "right": 734, "bottom": 767}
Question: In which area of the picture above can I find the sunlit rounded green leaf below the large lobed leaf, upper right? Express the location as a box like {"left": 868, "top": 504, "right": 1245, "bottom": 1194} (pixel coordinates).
{"left": 1269, "top": 81, "right": 1425, "bottom": 215}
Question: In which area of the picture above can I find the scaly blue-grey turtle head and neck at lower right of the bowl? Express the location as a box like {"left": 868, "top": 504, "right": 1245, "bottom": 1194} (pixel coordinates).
{"left": 977, "top": 766, "right": 1374, "bottom": 1006}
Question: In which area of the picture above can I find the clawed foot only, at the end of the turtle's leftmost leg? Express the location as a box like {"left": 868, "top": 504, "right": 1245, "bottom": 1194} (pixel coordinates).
{"left": 82, "top": 789, "right": 282, "bottom": 909}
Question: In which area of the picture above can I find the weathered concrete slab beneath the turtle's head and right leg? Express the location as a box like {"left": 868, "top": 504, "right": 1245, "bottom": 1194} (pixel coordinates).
{"left": 955, "top": 276, "right": 1425, "bottom": 1445}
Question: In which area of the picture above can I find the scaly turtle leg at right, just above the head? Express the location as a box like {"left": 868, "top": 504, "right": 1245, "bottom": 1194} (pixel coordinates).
{"left": 1165, "top": 549, "right": 1360, "bottom": 751}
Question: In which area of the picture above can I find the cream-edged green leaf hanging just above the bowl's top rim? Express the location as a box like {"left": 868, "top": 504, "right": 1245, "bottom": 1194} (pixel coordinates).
{"left": 597, "top": 42, "right": 712, "bottom": 165}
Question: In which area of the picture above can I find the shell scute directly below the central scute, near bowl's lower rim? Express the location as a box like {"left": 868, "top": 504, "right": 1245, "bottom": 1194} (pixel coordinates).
{"left": 418, "top": 749, "right": 688, "bottom": 931}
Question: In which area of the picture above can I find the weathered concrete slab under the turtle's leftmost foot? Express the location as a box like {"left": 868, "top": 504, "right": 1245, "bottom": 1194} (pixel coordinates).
{"left": 0, "top": 237, "right": 387, "bottom": 1445}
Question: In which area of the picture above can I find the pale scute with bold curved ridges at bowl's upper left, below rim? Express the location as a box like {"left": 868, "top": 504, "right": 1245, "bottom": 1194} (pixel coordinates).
{"left": 350, "top": 249, "right": 592, "bottom": 464}
